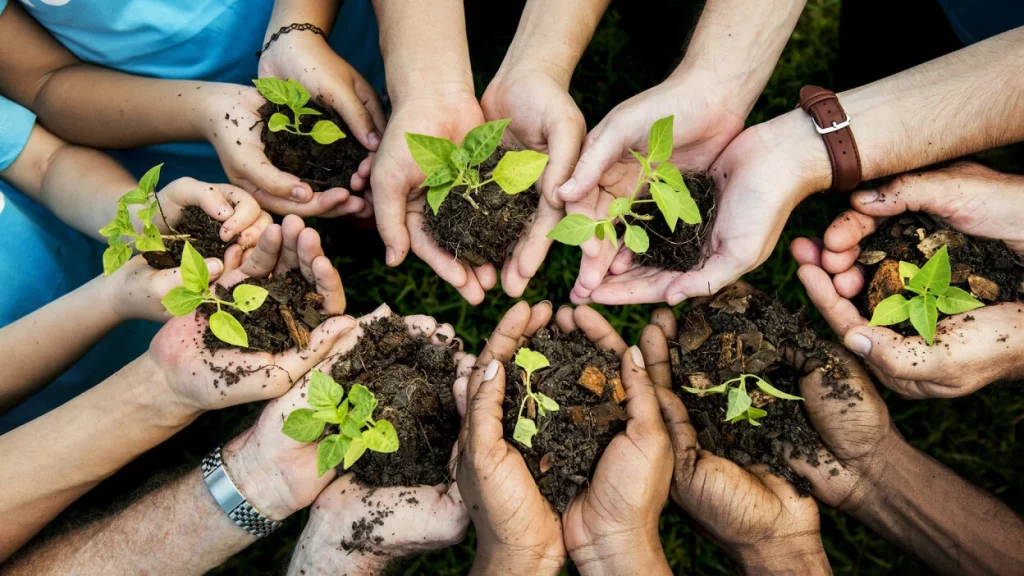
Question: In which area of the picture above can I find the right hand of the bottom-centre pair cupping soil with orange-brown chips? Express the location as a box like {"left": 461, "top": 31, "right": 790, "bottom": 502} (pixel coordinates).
{"left": 562, "top": 346, "right": 673, "bottom": 574}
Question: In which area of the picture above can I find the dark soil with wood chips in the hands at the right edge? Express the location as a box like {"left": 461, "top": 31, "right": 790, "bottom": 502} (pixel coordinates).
{"left": 855, "top": 212, "right": 1024, "bottom": 336}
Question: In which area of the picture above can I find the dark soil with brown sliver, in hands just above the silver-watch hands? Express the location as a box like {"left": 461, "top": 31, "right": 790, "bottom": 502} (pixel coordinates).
{"left": 199, "top": 271, "right": 328, "bottom": 354}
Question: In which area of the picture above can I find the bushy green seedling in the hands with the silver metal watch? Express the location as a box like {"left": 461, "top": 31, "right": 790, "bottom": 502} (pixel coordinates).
{"left": 281, "top": 370, "right": 398, "bottom": 476}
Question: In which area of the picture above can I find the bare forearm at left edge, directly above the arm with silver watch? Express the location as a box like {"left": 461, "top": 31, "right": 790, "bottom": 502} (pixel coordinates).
{"left": 0, "top": 355, "right": 198, "bottom": 559}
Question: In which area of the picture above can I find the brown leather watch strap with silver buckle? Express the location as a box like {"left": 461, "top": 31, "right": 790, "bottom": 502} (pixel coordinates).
{"left": 800, "top": 86, "right": 860, "bottom": 192}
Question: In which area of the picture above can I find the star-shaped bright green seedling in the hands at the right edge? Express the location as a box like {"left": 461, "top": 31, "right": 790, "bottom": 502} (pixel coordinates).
{"left": 870, "top": 246, "right": 985, "bottom": 345}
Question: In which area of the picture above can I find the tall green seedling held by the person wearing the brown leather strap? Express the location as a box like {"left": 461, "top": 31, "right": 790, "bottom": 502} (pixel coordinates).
{"left": 548, "top": 116, "right": 701, "bottom": 254}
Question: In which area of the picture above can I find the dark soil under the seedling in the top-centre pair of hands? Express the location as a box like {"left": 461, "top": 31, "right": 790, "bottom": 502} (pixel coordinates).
{"left": 423, "top": 149, "right": 540, "bottom": 268}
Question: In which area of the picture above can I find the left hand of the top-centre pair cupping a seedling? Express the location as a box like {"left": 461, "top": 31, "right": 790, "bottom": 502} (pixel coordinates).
{"left": 370, "top": 94, "right": 498, "bottom": 304}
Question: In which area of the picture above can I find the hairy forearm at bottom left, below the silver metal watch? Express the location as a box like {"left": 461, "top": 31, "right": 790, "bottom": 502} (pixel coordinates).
{"left": 5, "top": 469, "right": 256, "bottom": 574}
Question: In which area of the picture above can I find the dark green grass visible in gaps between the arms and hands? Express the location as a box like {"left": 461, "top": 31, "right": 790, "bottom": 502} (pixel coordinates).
{"left": 59, "top": 0, "right": 1024, "bottom": 575}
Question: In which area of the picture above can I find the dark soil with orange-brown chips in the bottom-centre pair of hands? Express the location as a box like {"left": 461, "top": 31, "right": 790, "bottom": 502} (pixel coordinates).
{"left": 502, "top": 328, "right": 626, "bottom": 512}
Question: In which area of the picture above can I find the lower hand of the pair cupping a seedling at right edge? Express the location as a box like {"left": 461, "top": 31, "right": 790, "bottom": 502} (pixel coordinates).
{"left": 792, "top": 238, "right": 1024, "bottom": 399}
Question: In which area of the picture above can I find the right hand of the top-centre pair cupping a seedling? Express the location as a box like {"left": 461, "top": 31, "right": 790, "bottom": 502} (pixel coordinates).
{"left": 480, "top": 68, "right": 587, "bottom": 298}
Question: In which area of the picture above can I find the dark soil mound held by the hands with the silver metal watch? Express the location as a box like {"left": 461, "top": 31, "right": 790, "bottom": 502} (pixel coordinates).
{"left": 333, "top": 316, "right": 460, "bottom": 487}
